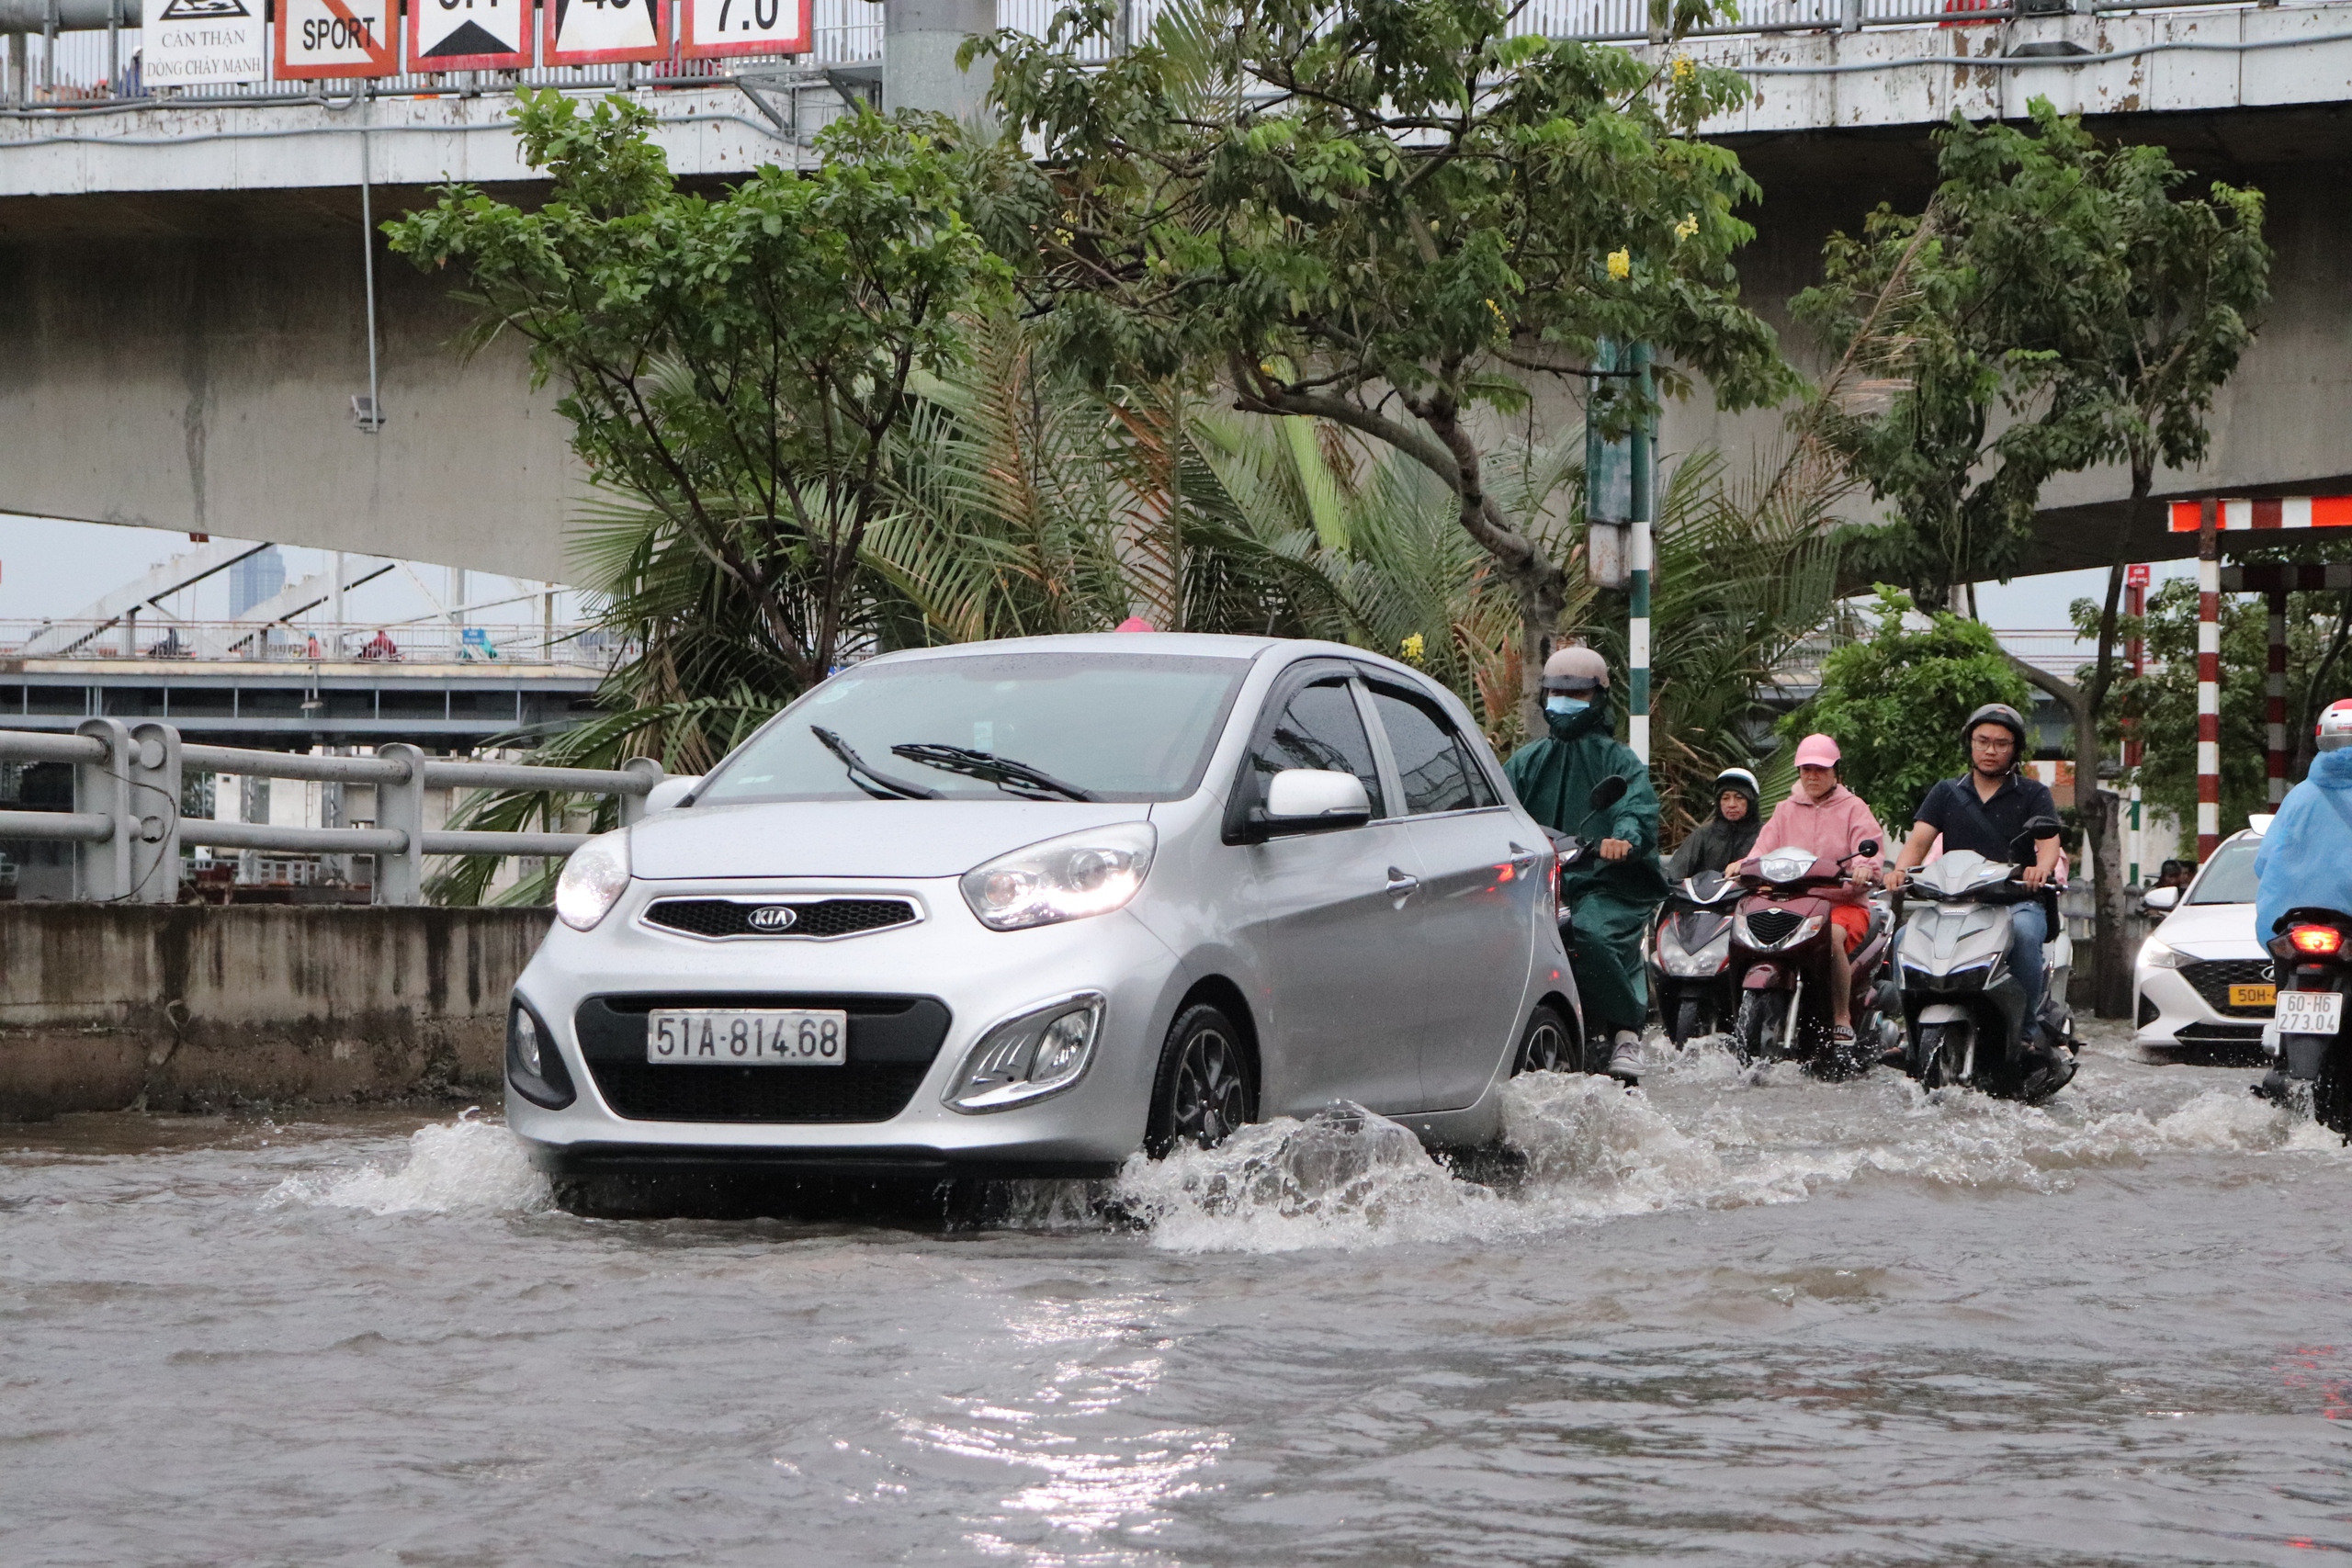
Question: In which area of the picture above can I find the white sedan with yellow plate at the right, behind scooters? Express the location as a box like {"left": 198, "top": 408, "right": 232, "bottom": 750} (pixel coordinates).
{"left": 2131, "top": 818, "right": 2277, "bottom": 1060}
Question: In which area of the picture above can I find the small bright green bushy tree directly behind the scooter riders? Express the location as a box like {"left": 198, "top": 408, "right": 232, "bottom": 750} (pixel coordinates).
{"left": 1781, "top": 583, "right": 2032, "bottom": 835}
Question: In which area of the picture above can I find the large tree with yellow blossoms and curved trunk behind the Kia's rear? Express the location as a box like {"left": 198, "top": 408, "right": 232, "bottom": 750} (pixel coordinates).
{"left": 965, "top": 0, "right": 1788, "bottom": 727}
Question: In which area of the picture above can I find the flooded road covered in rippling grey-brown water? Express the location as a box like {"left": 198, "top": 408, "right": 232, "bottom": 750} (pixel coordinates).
{"left": 0, "top": 1024, "right": 2352, "bottom": 1568}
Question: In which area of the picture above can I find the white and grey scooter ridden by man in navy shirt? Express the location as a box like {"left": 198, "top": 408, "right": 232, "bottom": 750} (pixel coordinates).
{"left": 1895, "top": 816, "right": 2075, "bottom": 1105}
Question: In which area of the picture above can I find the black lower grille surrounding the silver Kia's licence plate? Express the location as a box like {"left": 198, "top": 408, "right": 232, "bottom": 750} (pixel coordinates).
{"left": 571, "top": 992, "right": 950, "bottom": 1123}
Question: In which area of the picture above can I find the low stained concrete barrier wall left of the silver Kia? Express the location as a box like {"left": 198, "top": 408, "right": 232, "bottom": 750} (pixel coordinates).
{"left": 0, "top": 903, "right": 550, "bottom": 1122}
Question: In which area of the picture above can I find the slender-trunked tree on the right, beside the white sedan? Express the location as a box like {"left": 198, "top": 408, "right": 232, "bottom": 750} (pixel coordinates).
{"left": 1797, "top": 98, "right": 2269, "bottom": 1018}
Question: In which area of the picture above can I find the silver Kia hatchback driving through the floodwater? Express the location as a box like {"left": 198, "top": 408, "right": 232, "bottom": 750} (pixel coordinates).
{"left": 505, "top": 632, "right": 1580, "bottom": 1178}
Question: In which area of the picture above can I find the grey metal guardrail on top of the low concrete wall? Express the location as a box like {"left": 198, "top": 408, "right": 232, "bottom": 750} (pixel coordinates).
{"left": 0, "top": 719, "right": 663, "bottom": 903}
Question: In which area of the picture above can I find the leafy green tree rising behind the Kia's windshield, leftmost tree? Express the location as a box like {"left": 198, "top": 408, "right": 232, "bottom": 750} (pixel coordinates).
{"left": 386, "top": 89, "right": 1009, "bottom": 698}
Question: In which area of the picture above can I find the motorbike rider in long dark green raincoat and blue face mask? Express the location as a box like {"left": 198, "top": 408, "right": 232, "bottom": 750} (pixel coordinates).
{"left": 1503, "top": 649, "right": 1668, "bottom": 1084}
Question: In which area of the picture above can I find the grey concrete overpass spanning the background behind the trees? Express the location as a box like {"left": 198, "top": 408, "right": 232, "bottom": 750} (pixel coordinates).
{"left": 0, "top": 0, "right": 2352, "bottom": 581}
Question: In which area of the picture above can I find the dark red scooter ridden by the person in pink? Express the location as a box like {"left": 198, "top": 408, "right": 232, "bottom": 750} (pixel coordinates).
{"left": 1731, "top": 840, "right": 1891, "bottom": 1079}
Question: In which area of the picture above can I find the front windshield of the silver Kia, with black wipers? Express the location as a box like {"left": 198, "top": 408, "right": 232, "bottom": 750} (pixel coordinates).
{"left": 694, "top": 653, "right": 1249, "bottom": 804}
